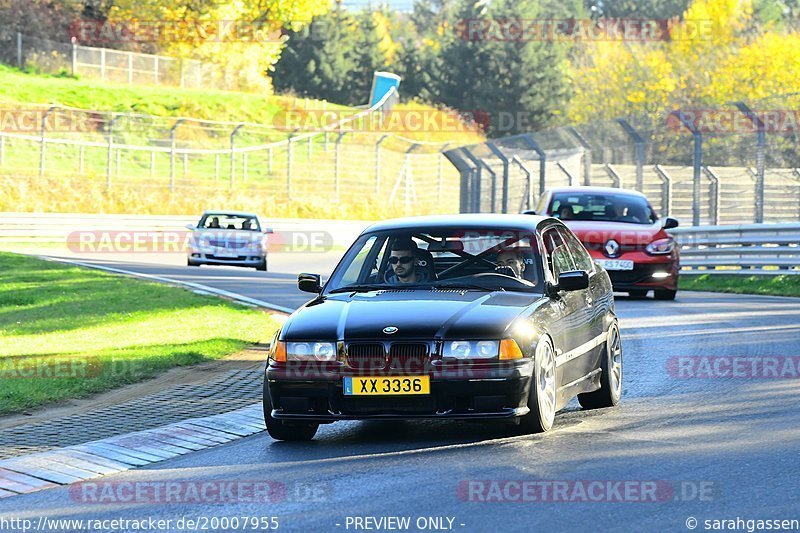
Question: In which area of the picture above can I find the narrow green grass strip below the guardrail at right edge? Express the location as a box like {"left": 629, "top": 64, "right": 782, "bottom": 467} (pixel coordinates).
{"left": 679, "top": 274, "right": 800, "bottom": 296}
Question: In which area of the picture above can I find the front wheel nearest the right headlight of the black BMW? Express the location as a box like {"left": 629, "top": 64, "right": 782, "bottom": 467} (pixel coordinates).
{"left": 518, "top": 337, "right": 556, "bottom": 433}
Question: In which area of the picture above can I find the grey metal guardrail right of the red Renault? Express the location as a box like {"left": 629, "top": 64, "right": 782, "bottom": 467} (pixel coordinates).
{"left": 670, "top": 222, "right": 800, "bottom": 275}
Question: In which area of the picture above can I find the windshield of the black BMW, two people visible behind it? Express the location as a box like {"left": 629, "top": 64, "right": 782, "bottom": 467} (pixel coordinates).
{"left": 325, "top": 228, "right": 542, "bottom": 293}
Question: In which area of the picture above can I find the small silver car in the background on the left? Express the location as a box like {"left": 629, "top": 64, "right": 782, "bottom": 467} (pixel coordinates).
{"left": 186, "top": 211, "right": 272, "bottom": 272}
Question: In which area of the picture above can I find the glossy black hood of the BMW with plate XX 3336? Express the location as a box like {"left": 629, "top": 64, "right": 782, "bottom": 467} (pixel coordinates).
{"left": 281, "top": 289, "right": 545, "bottom": 341}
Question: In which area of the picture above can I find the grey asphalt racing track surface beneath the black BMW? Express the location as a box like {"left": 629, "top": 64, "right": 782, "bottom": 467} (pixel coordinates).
{"left": 0, "top": 247, "right": 800, "bottom": 532}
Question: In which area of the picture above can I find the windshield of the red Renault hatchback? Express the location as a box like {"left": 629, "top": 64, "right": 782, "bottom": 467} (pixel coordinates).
{"left": 548, "top": 192, "right": 658, "bottom": 224}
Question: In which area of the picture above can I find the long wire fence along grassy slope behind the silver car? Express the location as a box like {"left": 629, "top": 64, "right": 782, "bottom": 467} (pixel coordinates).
{"left": 0, "top": 93, "right": 459, "bottom": 214}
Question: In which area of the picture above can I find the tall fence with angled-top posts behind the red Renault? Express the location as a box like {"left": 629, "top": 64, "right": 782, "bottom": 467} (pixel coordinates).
{"left": 445, "top": 94, "right": 800, "bottom": 226}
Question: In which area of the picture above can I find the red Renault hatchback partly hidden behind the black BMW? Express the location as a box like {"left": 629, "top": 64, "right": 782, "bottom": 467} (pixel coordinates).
{"left": 536, "top": 187, "right": 680, "bottom": 300}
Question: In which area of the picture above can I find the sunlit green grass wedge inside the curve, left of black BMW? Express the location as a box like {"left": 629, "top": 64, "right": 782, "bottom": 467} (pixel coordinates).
{"left": 0, "top": 253, "right": 278, "bottom": 414}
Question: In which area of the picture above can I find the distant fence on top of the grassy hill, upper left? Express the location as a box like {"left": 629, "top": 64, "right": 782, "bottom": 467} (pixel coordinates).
{"left": 0, "top": 32, "right": 264, "bottom": 92}
